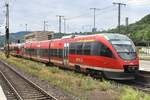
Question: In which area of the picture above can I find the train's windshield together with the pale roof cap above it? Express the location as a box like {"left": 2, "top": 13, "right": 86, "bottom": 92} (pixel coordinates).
{"left": 101, "top": 33, "right": 136, "bottom": 60}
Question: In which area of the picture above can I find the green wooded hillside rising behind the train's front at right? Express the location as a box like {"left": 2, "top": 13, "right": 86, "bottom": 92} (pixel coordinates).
{"left": 107, "top": 14, "right": 150, "bottom": 44}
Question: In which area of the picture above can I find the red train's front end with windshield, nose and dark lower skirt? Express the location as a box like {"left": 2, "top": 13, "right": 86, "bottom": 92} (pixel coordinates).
{"left": 102, "top": 34, "right": 139, "bottom": 80}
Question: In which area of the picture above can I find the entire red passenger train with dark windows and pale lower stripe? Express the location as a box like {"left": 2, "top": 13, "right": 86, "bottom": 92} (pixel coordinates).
{"left": 10, "top": 33, "right": 139, "bottom": 80}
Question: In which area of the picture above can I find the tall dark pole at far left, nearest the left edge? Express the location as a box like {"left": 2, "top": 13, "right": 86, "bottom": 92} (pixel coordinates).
{"left": 5, "top": 2, "right": 10, "bottom": 58}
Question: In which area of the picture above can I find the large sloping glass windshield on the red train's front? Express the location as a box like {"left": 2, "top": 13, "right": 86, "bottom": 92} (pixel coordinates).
{"left": 111, "top": 40, "right": 136, "bottom": 60}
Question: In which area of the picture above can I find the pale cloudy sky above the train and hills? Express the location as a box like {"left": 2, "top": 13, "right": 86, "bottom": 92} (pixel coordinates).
{"left": 0, "top": 0, "right": 150, "bottom": 34}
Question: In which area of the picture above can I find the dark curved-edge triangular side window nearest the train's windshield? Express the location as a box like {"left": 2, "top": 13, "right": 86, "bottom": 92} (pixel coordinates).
{"left": 100, "top": 44, "right": 113, "bottom": 58}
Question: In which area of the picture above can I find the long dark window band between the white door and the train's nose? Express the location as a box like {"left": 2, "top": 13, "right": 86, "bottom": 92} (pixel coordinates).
{"left": 69, "top": 42, "right": 113, "bottom": 57}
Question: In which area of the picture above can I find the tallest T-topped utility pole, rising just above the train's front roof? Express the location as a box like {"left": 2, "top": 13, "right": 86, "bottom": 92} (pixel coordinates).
{"left": 113, "top": 2, "right": 126, "bottom": 33}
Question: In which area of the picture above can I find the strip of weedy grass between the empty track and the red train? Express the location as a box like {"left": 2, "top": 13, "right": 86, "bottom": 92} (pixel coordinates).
{"left": 0, "top": 53, "right": 150, "bottom": 100}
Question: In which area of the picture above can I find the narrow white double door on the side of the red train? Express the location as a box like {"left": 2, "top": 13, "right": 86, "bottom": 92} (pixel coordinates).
{"left": 63, "top": 43, "right": 69, "bottom": 67}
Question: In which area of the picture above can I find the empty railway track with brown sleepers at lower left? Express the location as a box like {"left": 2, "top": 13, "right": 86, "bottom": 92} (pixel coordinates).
{"left": 0, "top": 61, "right": 57, "bottom": 100}
